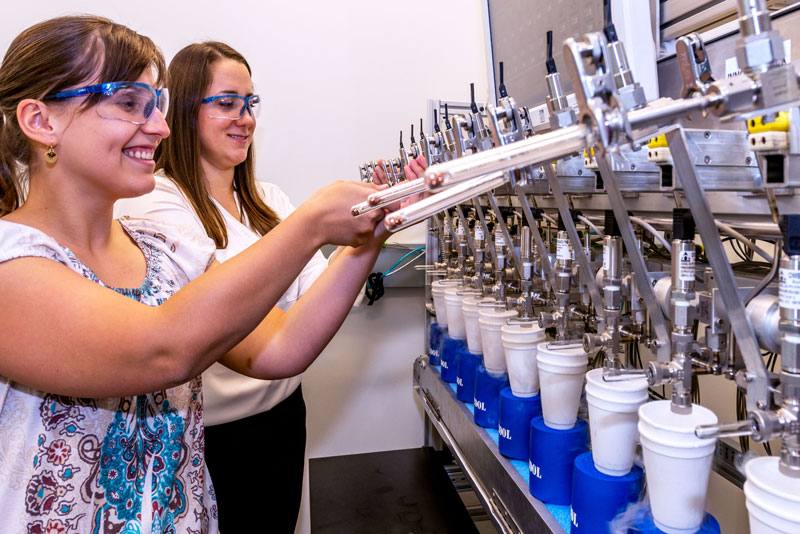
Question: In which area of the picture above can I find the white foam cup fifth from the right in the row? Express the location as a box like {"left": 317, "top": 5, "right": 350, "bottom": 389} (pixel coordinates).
{"left": 500, "top": 322, "right": 545, "bottom": 397}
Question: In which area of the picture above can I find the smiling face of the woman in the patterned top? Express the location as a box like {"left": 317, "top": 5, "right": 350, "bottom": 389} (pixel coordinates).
{"left": 56, "top": 69, "right": 169, "bottom": 200}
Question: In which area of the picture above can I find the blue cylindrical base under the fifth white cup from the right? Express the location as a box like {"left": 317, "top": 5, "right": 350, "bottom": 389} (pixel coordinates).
{"left": 497, "top": 388, "right": 542, "bottom": 460}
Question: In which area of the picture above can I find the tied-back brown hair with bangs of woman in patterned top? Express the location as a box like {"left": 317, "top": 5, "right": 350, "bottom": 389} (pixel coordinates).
{"left": 0, "top": 15, "right": 165, "bottom": 216}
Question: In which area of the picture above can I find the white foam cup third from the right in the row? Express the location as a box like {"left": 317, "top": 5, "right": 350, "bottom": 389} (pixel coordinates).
{"left": 586, "top": 369, "right": 647, "bottom": 477}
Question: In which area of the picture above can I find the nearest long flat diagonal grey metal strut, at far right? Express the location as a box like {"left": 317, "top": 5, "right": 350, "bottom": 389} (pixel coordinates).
{"left": 664, "top": 128, "right": 769, "bottom": 410}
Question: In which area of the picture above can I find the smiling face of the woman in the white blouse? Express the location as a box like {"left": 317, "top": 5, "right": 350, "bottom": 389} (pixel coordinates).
{"left": 197, "top": 58, "right": 256, "bottom": 180}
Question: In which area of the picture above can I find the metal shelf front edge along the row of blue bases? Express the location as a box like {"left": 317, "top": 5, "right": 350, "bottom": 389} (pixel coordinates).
{"left": 414, "top": 356, "right": 568, "bottom": 534}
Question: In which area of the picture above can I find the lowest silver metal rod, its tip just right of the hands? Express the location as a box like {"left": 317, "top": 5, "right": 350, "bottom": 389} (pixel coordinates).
{"left": 386, "top": 172, "right": 508, "bottom": 232}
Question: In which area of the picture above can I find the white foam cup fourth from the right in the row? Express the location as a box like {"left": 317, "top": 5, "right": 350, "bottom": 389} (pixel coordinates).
{"left": 536, "top": 341, "right": 589, "bottom": 430}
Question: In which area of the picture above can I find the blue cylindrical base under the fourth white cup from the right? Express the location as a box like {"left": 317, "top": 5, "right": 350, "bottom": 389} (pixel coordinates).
{"left": 528, "top": 415, "right": 589, "bottom": 505}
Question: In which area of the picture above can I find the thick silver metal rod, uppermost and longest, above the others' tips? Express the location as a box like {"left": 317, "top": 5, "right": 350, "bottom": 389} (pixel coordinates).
{"left": 425, "top": 124, "right": 591, "bottom": 189}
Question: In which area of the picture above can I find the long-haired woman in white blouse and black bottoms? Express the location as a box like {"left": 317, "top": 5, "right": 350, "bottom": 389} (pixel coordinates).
{"left": 116, "top": 42, "right": 424, "bottom": 532}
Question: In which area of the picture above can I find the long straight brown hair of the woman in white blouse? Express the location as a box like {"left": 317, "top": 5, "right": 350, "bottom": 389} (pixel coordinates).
{"left": 156, "top": 41, "right": 280, "bottom": 248}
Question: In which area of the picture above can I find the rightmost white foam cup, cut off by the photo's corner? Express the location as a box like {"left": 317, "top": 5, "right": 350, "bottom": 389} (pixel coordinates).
{"left": 744, "top": 456, "right": 800, "bottom": 534}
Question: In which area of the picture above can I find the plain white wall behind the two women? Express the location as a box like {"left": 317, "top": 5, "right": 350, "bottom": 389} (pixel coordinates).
{"left": 0, "top": 0, "right": 488, "bottom": 532}
